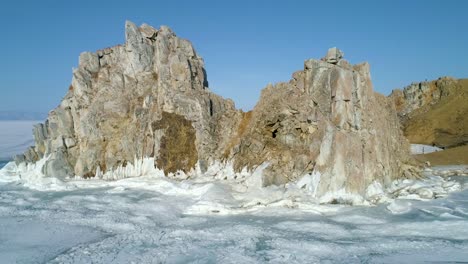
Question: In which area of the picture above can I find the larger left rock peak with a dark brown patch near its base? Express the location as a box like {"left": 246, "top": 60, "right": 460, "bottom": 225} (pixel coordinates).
{"left": 15, "top": 22, "right": 241, "bottom": 177}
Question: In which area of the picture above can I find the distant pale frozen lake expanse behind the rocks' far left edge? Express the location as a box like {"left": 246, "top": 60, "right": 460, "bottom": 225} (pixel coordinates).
{"left": 0, "top": 121, "right": 41, "bottom": 162}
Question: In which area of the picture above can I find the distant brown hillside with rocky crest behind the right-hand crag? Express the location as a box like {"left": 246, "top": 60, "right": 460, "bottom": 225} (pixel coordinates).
{"left": 390, "top": 77, "right": 468, "bottom": 148}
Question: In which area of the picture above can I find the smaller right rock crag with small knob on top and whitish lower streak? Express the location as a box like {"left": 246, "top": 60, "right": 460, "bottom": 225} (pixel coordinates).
{"left": 230, "top": 48, "right": 409, "bottom": 195}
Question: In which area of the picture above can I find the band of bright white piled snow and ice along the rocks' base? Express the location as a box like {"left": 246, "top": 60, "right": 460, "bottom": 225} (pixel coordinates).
{"left": 0, "top": 158, "right": 468, "bottom": 210}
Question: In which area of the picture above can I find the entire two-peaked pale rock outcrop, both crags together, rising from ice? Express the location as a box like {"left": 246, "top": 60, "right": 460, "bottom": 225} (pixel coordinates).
{"left": 16, "top": 22, "right": 411, "bottom": 197}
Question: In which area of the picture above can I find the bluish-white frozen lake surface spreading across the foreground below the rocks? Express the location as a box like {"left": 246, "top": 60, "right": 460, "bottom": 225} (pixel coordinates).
{"left": 0, "top": 120, "right": 468, "bottom": 263}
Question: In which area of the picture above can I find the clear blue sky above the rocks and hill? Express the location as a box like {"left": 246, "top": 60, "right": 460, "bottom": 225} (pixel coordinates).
{"left": 0, "top": 0, "right": 468, "bottom": 112}
